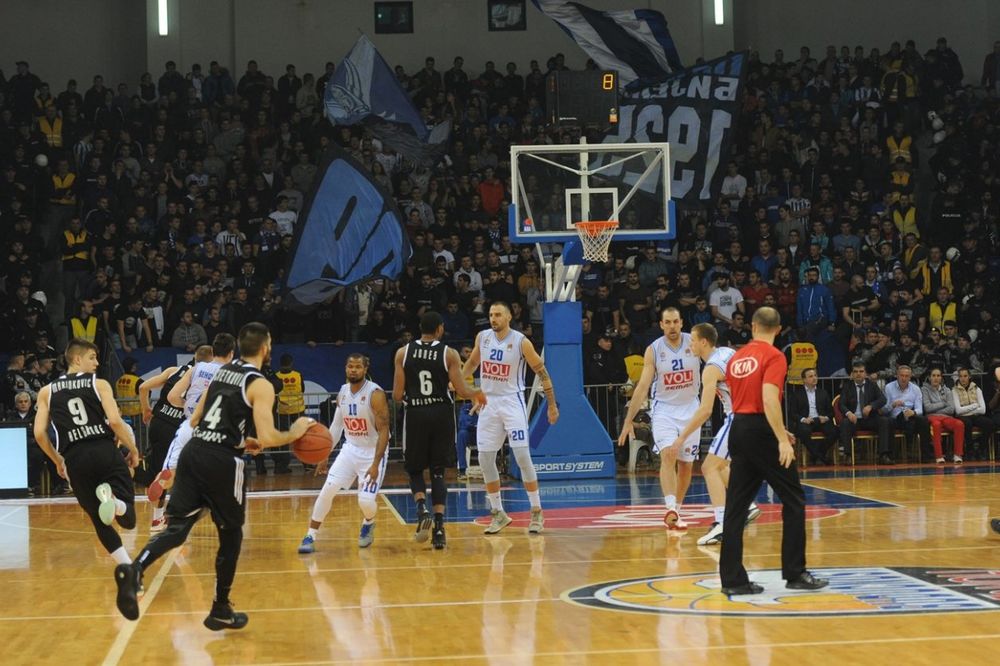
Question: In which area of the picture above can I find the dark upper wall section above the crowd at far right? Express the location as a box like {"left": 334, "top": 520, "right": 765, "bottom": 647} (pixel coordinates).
{"left": 734, "top": 0, "right": 1000, "bottom": 82}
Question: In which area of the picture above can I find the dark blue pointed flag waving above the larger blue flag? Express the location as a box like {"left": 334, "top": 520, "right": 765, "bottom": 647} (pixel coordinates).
{"left": 323, "top": 35, "right": 448, "bottom": 166}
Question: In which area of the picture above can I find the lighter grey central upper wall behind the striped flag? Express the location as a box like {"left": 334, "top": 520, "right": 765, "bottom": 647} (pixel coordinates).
{"left": 145, "top": 0, "right": 732, "bottom": 78}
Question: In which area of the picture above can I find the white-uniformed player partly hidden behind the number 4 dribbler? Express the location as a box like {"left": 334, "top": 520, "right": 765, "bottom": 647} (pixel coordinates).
{"left": 146, "top": 333, "right": 236, "bottom": 531}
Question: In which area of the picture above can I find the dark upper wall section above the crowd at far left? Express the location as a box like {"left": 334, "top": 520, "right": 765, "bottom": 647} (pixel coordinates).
{"left": 0, "top": 0, "right": 146, "bottom": 93}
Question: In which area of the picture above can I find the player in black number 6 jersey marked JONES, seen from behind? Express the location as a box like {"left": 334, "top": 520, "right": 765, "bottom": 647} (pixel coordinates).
{"left": 392, "top": 311, "right": 486, "bottom": 550}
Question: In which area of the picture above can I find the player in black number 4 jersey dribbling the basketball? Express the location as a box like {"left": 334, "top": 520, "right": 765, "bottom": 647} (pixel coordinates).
{"left": 115, "top": 322, "right": 314, "bottom": 631}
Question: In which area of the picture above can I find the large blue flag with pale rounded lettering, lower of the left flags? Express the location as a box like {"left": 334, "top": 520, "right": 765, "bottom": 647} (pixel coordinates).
{"left": 285, "top": 147, "right": 410, "bottom": 307}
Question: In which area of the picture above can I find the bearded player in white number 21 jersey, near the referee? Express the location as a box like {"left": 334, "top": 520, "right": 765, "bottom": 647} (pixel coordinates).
{"left": 618, "top": 307, "right": 701, "bottom": 532}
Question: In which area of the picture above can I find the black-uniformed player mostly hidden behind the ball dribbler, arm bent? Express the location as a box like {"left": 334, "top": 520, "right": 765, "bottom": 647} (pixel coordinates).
{"left": 139, "top": 345, "right": 212, "bottom": 534}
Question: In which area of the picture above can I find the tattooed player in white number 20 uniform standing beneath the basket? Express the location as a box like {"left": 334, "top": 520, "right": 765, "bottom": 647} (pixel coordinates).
{"left": 462, "top": 301, "right": 559, "bottom": 534}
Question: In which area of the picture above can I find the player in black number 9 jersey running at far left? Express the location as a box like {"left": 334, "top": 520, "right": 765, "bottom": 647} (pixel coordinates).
{"left": 35, "top": 339, "right": 139, "bottom": 565}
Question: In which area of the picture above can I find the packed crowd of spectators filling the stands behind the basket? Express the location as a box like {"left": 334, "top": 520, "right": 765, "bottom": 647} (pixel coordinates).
{"left": 0, "top": 39, "right": 1000, "bottom": 416}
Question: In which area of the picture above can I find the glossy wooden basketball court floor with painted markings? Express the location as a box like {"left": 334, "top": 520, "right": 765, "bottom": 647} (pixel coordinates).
{"left": 0, "top": 464, "right": 1000, "bottom": 666}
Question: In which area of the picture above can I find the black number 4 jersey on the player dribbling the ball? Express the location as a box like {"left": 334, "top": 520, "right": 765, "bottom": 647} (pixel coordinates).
{"left": 192, "top": 361, "right": 264, "bottom": 455}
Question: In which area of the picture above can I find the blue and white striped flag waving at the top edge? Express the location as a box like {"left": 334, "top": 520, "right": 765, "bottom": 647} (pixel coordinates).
{"left": 532, "top": 0, "right": 683, "bottom": 88}
